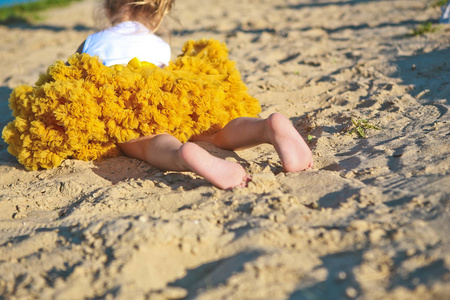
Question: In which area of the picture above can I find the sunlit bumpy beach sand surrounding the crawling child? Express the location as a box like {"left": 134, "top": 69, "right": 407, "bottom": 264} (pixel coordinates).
{"left": 0, "top": 0, "right": 450, "bottom": 300}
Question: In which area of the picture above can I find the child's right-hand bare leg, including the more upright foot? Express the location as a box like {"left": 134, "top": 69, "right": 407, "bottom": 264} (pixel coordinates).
{"left": 196, "top": 113, "right": 313, "bottom": 172}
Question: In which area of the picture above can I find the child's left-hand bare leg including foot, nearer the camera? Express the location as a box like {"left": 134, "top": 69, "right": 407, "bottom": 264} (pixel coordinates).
{"left": 119, "top": 134, "right": 248, "bottom": 189}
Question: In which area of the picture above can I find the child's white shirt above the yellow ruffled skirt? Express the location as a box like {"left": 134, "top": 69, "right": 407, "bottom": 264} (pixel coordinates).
{"left": 83, "top": 21, "right": 170, "bottom": 67}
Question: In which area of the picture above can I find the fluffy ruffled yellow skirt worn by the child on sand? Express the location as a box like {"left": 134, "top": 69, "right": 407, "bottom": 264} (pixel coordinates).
{"left": 2, "top": 40, "right": 261, "bottom": 170}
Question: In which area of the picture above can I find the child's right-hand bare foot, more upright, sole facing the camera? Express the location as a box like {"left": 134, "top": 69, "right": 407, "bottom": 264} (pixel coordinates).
{"left": 267, "top": 113, "right": 313, "bottom": 172}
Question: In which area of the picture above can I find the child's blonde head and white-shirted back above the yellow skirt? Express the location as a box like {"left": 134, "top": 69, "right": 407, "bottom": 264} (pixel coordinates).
{"left": 77, "top": 0, "right": 175, "bottom": 66}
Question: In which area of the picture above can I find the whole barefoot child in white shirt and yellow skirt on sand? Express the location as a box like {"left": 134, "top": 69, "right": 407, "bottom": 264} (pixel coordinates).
{"left": 2, "top": 0, "right": 313, "bottom": 189}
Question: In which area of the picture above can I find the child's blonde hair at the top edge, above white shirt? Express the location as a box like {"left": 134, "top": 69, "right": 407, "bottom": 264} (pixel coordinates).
{"left": 105, "top": 0, "right": 175, "bottom": 32}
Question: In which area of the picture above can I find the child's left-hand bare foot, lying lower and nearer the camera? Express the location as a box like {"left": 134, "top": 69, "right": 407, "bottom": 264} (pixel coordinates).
{"left": 178, "top": 142, "right": 250, "bottom": 189}
